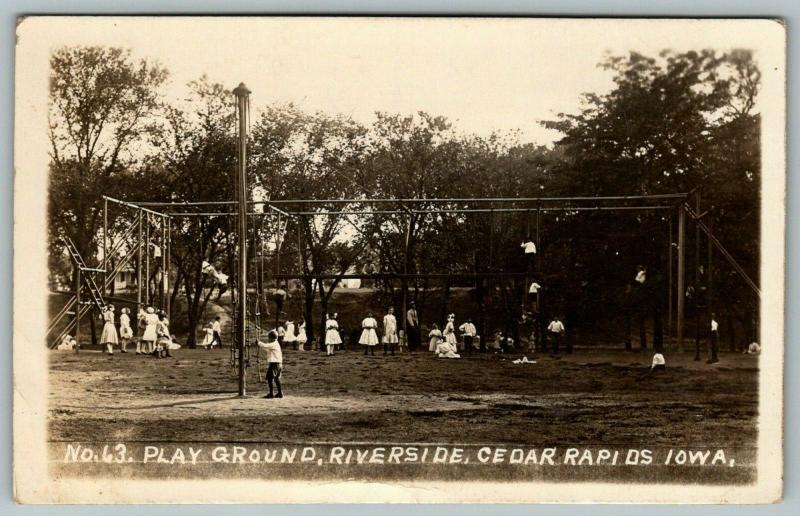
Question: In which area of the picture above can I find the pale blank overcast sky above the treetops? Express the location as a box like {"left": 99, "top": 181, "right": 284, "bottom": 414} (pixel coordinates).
{"left": 36, "top": 18, "right": 758, "bottom": 144}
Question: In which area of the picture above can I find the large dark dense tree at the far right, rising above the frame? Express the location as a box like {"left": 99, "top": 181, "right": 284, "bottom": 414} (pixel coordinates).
{"left": 544, "top": 50, "right": 760, "bottom": 338}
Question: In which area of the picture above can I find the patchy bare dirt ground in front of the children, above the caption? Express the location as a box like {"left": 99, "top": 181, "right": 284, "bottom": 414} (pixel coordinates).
{"left": 49, "top": 348, "right": 758, "bottom": 482}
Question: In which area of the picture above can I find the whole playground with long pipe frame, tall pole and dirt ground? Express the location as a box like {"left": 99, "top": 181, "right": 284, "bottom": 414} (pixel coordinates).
{"left": 48, "top": 79, "right": 761, "bottom": 483}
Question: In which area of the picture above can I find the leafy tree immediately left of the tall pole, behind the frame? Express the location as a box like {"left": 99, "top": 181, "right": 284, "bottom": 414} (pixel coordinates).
{"left": 145, "top": 77, "right": 237, "bottom": 347}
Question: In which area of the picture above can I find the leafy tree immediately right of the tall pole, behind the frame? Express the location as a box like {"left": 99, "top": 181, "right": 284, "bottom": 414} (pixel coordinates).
{"left": 251, "top": 105, "right": 367, "bottom": 344}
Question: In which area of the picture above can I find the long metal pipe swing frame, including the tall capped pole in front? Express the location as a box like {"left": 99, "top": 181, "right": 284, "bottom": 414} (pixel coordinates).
{"left": 50, "top": 83, "right": 761, "bottom": 396}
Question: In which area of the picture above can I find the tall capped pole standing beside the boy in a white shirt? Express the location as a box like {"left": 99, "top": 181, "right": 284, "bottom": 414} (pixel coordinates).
{"left": 233, "top": 82, "right": 250, "bottom": 396}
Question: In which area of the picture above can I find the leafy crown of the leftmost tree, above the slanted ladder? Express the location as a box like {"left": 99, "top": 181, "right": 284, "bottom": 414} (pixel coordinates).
{"left": 49, "top": 47, "right": 167, "bottom": 282}
